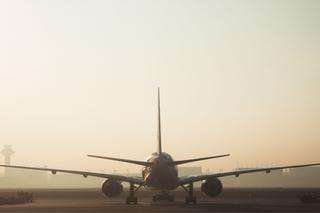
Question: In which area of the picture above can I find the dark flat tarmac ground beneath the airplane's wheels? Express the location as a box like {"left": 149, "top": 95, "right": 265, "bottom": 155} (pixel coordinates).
{"left": 0, "top": 189, "right": 320, "bottom": 213}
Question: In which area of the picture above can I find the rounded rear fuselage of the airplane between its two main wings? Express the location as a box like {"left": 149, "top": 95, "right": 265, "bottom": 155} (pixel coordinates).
{"left": 142, "top": 152, "right": 178, "bottom": 190}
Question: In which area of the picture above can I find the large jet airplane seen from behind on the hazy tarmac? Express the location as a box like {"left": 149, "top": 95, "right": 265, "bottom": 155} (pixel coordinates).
{"left": 0, "top": 88, "right": 320, "bottom": 204}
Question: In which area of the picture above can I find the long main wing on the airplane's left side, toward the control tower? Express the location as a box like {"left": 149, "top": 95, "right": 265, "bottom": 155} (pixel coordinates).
{"left": 0, "top": 165, "right": 144, "bottom": 185}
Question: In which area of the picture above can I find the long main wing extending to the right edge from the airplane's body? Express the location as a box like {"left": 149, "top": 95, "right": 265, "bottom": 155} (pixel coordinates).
{"left": 179, "top": 163, "right": 320, "bottom": 185}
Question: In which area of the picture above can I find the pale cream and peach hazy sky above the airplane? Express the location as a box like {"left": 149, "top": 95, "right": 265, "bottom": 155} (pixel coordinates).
{"left": 0, "top": 0, "right": 320, "bottom": 175}
